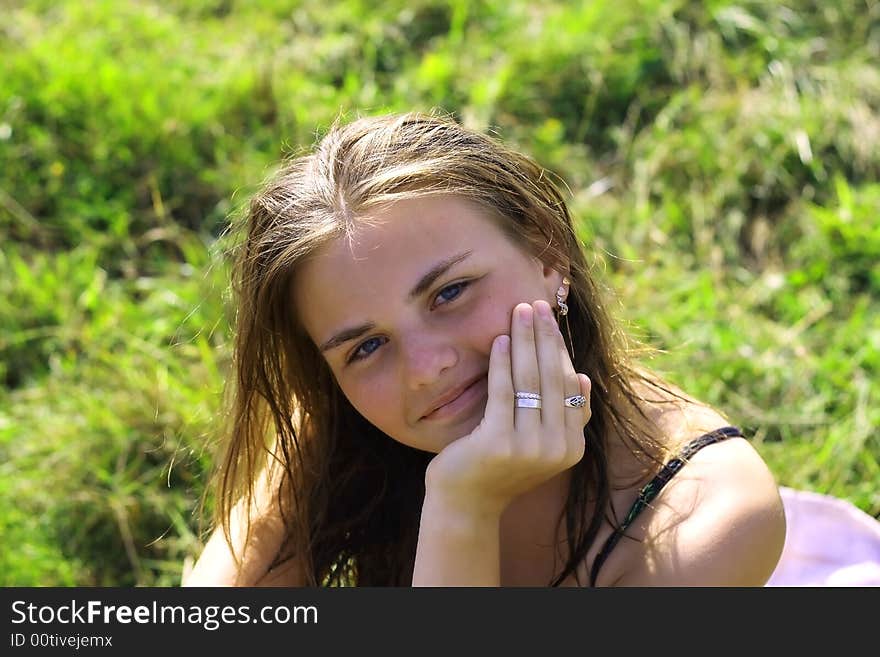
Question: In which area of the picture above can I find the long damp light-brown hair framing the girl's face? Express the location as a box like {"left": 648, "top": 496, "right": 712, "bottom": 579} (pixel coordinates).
{"left": 215, "top": 113, "right": 659, "bottom": 585}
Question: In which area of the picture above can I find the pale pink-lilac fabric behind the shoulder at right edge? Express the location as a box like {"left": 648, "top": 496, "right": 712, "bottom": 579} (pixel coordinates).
{"left": 767, "top": 486, "right": 880, "bottom": 586}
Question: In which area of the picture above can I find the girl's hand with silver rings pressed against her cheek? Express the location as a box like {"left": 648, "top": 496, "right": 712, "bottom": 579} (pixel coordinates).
{"left": 426, "top": 300, "right": 590, "bottom": 516}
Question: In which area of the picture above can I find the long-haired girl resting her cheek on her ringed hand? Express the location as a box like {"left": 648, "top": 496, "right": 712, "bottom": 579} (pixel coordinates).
{"left": 186, "top": 114, "right": 785, "bottom": 586}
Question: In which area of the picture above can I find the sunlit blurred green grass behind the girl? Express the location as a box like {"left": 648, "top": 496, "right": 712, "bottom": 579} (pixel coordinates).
{"left": 0, "top": 0, "right": 880, "bottom": 586}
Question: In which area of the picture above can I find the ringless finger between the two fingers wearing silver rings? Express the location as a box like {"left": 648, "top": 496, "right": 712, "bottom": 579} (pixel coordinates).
{"left": 533, "top": 300, "right": 565, "bottom": 439}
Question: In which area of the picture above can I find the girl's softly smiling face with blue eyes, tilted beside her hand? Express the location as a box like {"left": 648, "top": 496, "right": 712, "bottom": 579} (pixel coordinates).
{"left": 293, "top": 196, "right": 562, "bottom": 452}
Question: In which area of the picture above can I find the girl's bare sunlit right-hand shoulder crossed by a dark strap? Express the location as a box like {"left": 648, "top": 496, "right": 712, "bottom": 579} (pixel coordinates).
{"left": 599, "top": 376, "right": 785, "bottom": 586}
